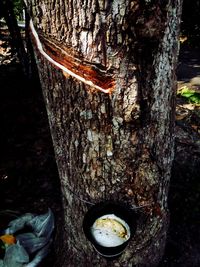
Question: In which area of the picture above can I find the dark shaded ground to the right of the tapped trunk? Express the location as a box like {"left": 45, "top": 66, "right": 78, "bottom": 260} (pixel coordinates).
{"left": 159, "top": 46, "right": 200, "bottom": 267}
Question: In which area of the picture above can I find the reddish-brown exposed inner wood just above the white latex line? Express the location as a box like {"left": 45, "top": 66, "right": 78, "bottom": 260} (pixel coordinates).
{"left": 31, "top": 25, "right": 115, "bottom": 93}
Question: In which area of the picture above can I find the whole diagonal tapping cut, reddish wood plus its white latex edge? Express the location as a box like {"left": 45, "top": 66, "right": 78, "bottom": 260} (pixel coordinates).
{"left": 30, "top": 19, "right": 115, "bottom": 94}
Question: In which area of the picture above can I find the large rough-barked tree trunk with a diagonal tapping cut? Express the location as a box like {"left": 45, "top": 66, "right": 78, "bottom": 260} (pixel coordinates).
{"left": 27, "top": 0, "right": 181, "bottom": 267}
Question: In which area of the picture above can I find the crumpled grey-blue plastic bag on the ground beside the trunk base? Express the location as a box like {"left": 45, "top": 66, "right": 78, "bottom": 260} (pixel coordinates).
{"left": 0, "top": 209, "right": 54, "bottom": 267}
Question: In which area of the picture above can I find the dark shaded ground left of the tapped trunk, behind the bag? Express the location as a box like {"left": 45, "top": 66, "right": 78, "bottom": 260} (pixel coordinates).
{"left": 0, "top": 34, "right": 62, "bottom": 267}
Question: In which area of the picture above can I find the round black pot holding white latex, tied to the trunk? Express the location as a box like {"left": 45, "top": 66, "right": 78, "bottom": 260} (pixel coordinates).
{"left": 83, "top": 202, "right": 136, "bottom": 259}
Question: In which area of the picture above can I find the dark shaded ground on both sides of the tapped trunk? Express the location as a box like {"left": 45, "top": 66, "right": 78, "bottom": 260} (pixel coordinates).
{"left": 0, "top": 30, "right": 200, "bottom": 267}
